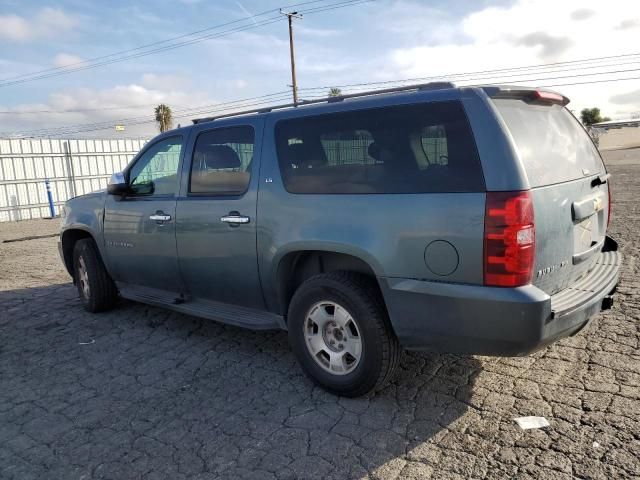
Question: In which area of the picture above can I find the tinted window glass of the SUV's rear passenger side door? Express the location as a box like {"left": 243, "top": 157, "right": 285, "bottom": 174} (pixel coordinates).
{"left": 189, "top": 127, "right": 254, "bottom": 195}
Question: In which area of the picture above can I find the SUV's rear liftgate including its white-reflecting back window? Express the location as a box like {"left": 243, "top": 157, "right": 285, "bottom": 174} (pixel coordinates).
{"left": 493, "top": 96, "right": 609, "bottom": 295}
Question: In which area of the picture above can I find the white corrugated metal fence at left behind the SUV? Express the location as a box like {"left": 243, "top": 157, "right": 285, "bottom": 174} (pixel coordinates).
{"left": 0, "top": 138, "right": 147, "bottom": 222}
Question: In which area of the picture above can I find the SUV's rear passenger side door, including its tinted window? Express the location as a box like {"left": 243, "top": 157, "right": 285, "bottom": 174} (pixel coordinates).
{"left": 176, "top": 119, "right": 264, "bottom": 309}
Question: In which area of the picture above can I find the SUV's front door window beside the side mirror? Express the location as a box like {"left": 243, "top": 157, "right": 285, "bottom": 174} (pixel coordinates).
{"left": 129, "top": 136, "right": 182, "bottom": 195}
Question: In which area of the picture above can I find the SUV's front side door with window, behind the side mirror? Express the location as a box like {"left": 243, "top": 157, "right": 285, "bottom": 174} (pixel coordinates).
{"left": 104, "top": 135, "right": 183, "bottom": 295}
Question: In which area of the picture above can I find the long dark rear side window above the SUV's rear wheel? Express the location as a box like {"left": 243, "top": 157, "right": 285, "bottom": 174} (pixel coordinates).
{"left": 276, "top": 101, "right": 484, "bottom": 194}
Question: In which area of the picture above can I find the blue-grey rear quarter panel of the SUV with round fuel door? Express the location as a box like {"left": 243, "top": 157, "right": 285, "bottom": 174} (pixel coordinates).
{"left": 257, "top": 105, "right": 485, "bottom": 313}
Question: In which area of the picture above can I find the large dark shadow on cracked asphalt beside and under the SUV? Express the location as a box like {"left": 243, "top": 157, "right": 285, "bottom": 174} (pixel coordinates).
{"left": 0, "top": 284, "right": 481, "bottom": 478}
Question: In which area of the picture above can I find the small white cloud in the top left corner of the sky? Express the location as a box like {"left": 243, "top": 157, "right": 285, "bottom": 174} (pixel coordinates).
{"left": 0, "top": 7, "right": 78, "bottom": 42}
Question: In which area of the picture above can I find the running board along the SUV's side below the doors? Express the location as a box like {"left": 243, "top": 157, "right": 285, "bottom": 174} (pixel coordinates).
{"left": 116, "top": 282, "right": 285, "bottom": 330}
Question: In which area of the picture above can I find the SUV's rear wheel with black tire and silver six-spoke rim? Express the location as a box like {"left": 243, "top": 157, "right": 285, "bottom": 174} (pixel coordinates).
{"left": 288, "top": 272, "right": 401, "bottom": 397}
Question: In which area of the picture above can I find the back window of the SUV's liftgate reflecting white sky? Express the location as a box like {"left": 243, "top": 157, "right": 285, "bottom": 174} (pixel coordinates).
{"left": 494, "top": 99, "right": 604, "bottom": 187}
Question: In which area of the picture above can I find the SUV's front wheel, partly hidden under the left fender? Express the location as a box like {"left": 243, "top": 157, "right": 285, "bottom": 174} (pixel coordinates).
{"left": 73, "top": 238, "right": 118, "bottom": 313}
